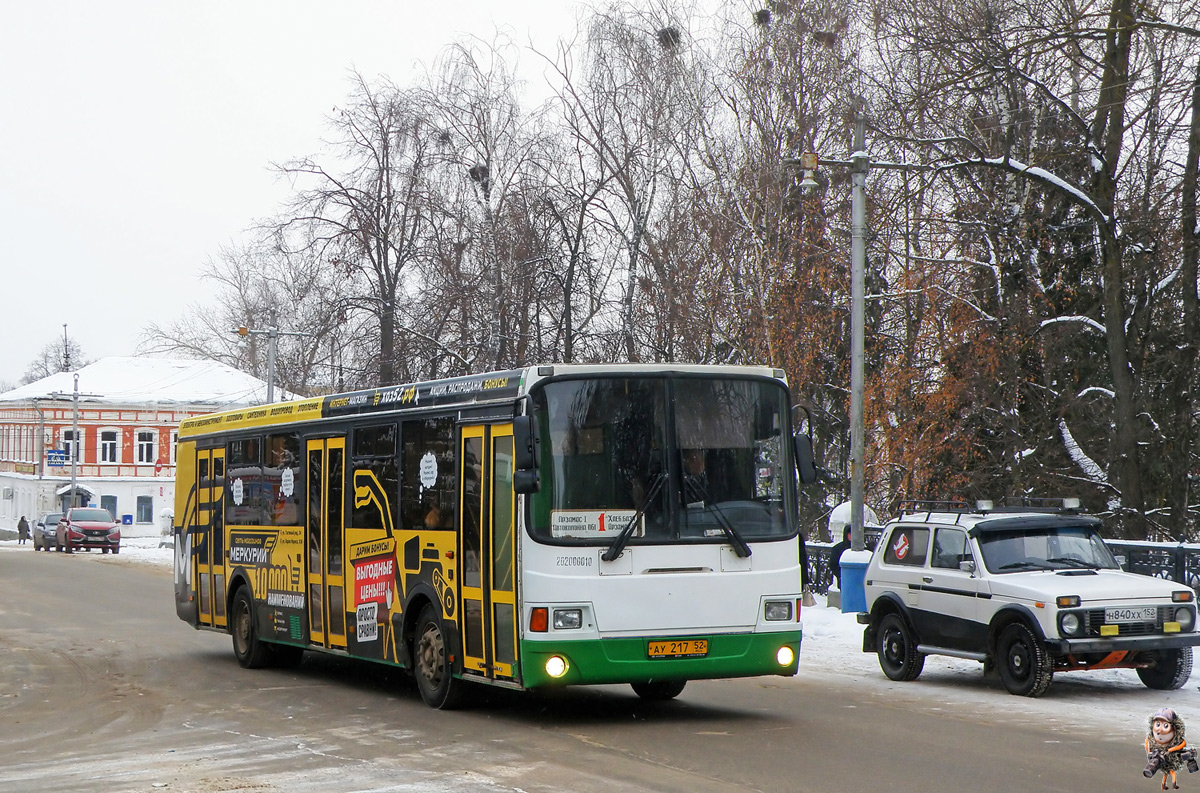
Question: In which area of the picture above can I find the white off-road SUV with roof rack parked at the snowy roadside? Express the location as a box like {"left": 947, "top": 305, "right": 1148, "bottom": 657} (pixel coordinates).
{"left": 858, "top": 499, "right": 1200, "bottom": 697}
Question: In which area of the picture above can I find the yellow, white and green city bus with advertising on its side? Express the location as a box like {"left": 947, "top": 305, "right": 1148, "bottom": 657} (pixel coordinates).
{"left": 173, "top": 365, "right": 816, "bottom": 708}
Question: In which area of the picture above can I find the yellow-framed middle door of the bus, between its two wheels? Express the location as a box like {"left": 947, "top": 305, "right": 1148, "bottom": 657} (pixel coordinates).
{"left": 305, "top": 438, "right": 346, "bottom": 650}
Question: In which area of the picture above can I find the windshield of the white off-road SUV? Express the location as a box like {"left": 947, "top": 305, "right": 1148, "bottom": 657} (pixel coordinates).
{"left": 979, "top": 527, "right": 1120, "bottom": 572}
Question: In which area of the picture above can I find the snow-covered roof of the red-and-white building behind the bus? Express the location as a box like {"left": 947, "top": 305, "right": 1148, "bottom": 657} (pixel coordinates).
{"left": 0, "top": 358, "right": 300, "bottom": 409}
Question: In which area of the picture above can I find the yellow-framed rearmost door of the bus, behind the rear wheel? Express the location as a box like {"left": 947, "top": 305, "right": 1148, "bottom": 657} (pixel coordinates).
{"left": 192, "top": 446, "right": 226, "bottom": 627}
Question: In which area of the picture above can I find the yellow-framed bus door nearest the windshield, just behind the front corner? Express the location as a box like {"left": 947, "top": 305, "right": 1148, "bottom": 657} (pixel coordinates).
{"left": 458, "top": 423, "right": 518, "bottom": 680}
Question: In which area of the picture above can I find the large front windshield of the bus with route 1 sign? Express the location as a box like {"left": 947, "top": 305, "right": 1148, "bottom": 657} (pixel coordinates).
{"left": 529, "top": 376, "right": 794, "bottom": 545}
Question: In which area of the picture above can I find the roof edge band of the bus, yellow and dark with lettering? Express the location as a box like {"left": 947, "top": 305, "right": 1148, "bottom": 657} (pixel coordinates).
{"left": 179, "top": 364, "right": 787, "bottom": 439}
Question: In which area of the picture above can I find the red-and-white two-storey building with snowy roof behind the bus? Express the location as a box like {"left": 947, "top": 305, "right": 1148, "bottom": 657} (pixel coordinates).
{"left": 0, "top": 358, "right": 282, "bottom": 535}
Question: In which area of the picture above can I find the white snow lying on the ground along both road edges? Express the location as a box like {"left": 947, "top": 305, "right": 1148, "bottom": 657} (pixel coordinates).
{"left": 0, "top": 536, "right": 1200, "bottom": 743}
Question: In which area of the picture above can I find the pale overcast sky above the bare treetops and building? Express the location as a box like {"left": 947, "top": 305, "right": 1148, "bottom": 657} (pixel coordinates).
{"left": 0, "top": 0, "right": 578, "bottom": 385}
